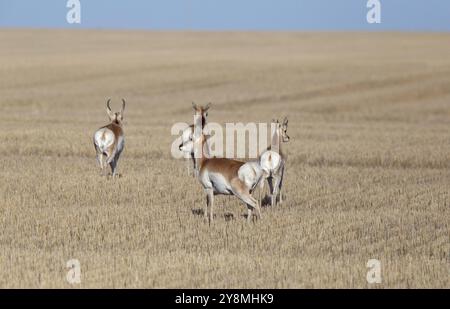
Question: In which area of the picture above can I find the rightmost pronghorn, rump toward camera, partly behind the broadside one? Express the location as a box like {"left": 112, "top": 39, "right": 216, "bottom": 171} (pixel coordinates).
{"left": 260, "top": 117, "right": 289, "bottom": 206}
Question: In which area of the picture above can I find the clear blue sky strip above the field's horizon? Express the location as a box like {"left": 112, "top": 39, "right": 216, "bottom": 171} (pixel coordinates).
{"left": 0, "top": 0, "right": 450, "bottom": 31}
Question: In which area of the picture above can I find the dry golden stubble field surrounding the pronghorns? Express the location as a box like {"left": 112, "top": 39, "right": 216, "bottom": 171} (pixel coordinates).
{"left": 0, "top": 30, "right": 450, "bottom": 288}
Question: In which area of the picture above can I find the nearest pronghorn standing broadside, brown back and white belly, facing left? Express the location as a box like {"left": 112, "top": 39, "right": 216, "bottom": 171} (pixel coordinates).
{"left": 180, "top": 105, "right": 262, "bottom": 223}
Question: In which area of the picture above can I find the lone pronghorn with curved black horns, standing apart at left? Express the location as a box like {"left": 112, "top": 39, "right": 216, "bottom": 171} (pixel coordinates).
{"left": 94, "top": 99, "right": 125, "bottom": 177}
